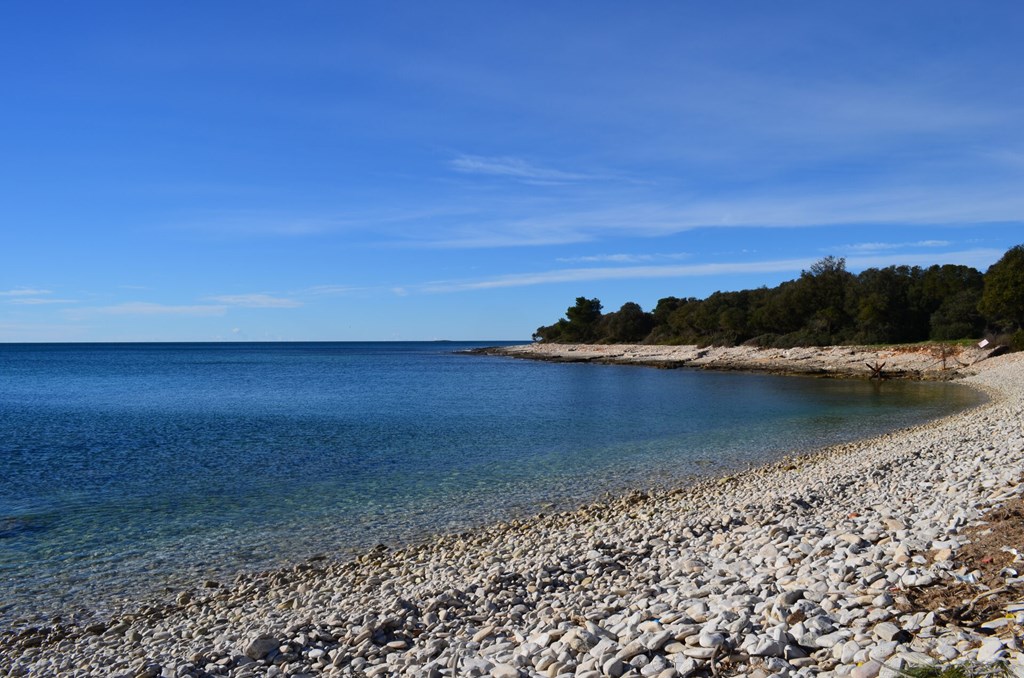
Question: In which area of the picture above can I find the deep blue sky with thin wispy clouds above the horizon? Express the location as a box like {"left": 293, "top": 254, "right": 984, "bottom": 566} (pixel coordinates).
{"left": 0, "top": 0, "right": 1024, "bottom": 341}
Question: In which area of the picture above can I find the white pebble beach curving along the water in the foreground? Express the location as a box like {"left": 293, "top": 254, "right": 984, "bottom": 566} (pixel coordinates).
{"left": 0, "top": 347, "right": 1024, "bottom": 678}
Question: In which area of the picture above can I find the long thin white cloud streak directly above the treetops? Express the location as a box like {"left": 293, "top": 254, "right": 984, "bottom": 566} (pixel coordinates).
{"left": 419, "top": 249, "right": 1002, "bottom": 294}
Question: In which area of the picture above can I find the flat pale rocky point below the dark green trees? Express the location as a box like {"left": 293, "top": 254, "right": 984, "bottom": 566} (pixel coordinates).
{"left": 472, "top": 343, "right": 998, "bottom": 380}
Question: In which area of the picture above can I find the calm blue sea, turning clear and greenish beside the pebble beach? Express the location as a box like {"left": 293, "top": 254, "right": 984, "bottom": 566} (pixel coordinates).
{"left": 0, "top": 343, "right": 978, "bottom": 628}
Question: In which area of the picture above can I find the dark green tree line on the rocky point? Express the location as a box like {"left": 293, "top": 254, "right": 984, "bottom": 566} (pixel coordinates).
{"left": 534, "top": 245, "right": 1024, "bottom": 349}
